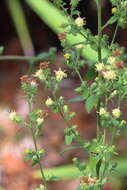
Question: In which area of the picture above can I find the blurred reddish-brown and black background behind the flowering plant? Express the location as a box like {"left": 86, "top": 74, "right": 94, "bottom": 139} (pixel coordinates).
{"left": 0, "top": 0, "right": 127, "bottom": 190}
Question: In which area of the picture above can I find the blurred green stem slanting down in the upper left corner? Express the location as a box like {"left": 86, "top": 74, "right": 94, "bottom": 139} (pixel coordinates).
{"left": 5, "top": 0, "right": 34, "bottom": 55}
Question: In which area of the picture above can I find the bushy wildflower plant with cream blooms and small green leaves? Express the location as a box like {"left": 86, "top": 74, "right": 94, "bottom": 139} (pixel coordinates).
{"left": 6, "top": 0, "right": 127, "bottom": 190}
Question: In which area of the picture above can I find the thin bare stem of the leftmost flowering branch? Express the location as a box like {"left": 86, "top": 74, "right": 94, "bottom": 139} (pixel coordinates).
{"left": 28, "top": 100, "right": 47, "bottom": 189}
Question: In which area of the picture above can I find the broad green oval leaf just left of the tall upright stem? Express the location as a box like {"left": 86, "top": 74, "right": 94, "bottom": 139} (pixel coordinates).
{"left": 85, "top": 95, "right": 99, "bottom": 113}
